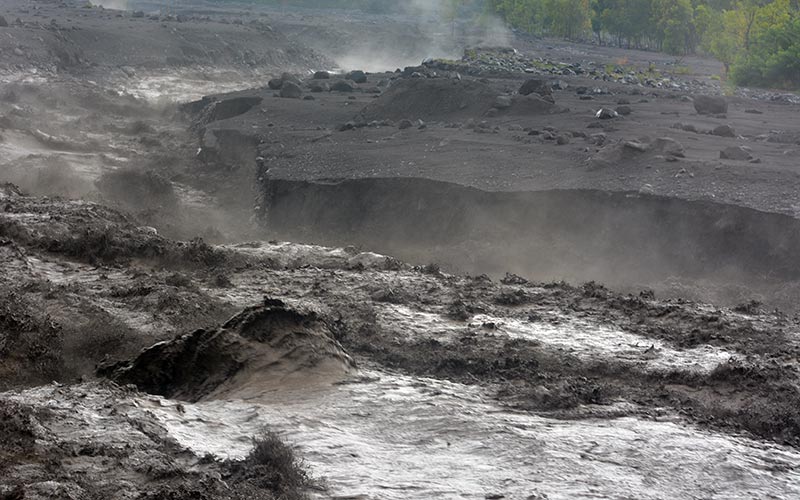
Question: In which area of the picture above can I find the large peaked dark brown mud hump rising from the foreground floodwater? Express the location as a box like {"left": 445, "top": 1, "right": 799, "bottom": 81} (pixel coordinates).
{"left": 104, "top": 299, "right": 355, "bottom": 401}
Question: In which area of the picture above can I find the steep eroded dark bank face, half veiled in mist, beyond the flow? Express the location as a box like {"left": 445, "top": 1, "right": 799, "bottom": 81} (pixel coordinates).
{"left": 264, "top": 178, "right": 800, "bottom": 308}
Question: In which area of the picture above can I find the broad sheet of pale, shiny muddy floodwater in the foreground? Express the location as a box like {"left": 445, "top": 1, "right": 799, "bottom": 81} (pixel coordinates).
{"left": 145, "top": 370, "right": 800, "bottom": 499}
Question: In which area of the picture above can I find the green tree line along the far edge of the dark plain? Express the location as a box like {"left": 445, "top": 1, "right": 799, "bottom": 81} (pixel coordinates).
{"left": 486, "top": 0, "right": 800, "bottom": 89}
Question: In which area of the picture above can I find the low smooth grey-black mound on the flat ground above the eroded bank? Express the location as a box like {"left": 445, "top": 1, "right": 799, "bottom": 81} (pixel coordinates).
{"left": 362, "top": 78, "right": 497, "bottom": 120}
